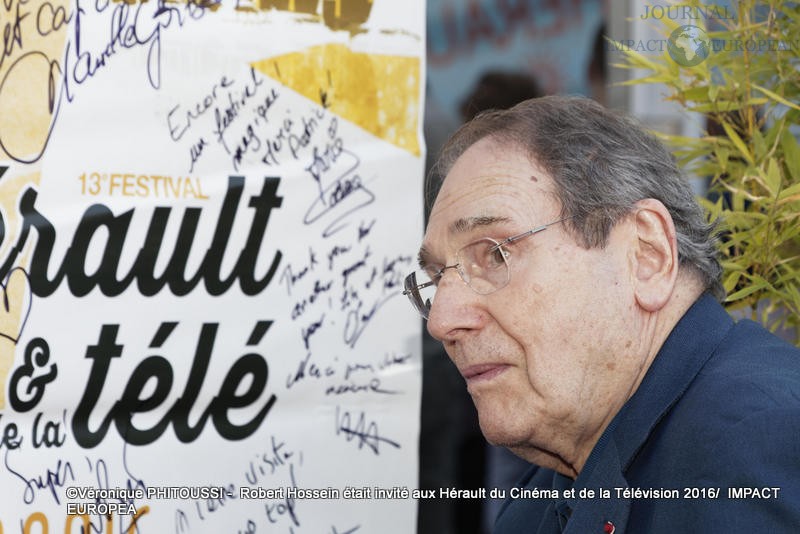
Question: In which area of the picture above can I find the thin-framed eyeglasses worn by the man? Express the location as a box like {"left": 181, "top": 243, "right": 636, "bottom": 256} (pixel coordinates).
{"left": 403, "top": 217, "right": 568, "bottom": 319}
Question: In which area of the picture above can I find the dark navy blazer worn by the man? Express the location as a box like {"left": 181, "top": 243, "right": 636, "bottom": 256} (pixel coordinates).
{"left": 494, "top": 295, "right": 800, "bottom": 534}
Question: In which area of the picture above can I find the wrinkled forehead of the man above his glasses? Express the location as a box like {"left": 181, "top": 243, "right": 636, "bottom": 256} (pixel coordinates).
{"left": 425, "top": 138, "right": 560, "bottom": 247}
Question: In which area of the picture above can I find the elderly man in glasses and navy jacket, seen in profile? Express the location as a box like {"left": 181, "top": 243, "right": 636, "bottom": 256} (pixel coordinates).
{"left": 405, "top": 97, "right": 800, "bottom": 534}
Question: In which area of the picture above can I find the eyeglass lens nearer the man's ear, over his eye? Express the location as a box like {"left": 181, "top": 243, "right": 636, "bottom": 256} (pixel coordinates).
{"left": 458, "top": 237, "right": 509, "bottom": 295}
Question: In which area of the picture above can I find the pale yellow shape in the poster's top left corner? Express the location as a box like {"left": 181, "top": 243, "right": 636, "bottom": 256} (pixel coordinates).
{"left": 0, "top": 0, "right": 72, "bottom": 161}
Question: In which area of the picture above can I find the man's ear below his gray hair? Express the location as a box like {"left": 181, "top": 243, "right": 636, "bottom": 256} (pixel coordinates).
{"left": 633, "top": 198, "right": 678, "bottom": 312}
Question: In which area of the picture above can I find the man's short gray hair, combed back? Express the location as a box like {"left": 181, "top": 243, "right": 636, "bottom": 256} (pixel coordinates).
{"left": 426, "top": 96, "right": 725, "bottom": 301}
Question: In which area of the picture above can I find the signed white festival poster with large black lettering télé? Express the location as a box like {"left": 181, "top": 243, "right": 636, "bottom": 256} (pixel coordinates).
{"left": 0, "top": 0, "right": 425, "bottom": 534}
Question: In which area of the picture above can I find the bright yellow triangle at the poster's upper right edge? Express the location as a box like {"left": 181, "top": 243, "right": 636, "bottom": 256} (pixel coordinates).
{"left": 252, "top": 44, "right": 420, "bottom": 156}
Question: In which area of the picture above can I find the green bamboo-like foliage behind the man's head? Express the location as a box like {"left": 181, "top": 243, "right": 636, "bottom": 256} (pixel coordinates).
{"left": 616, "top": 0, "right": 800, "bottom": 343}
